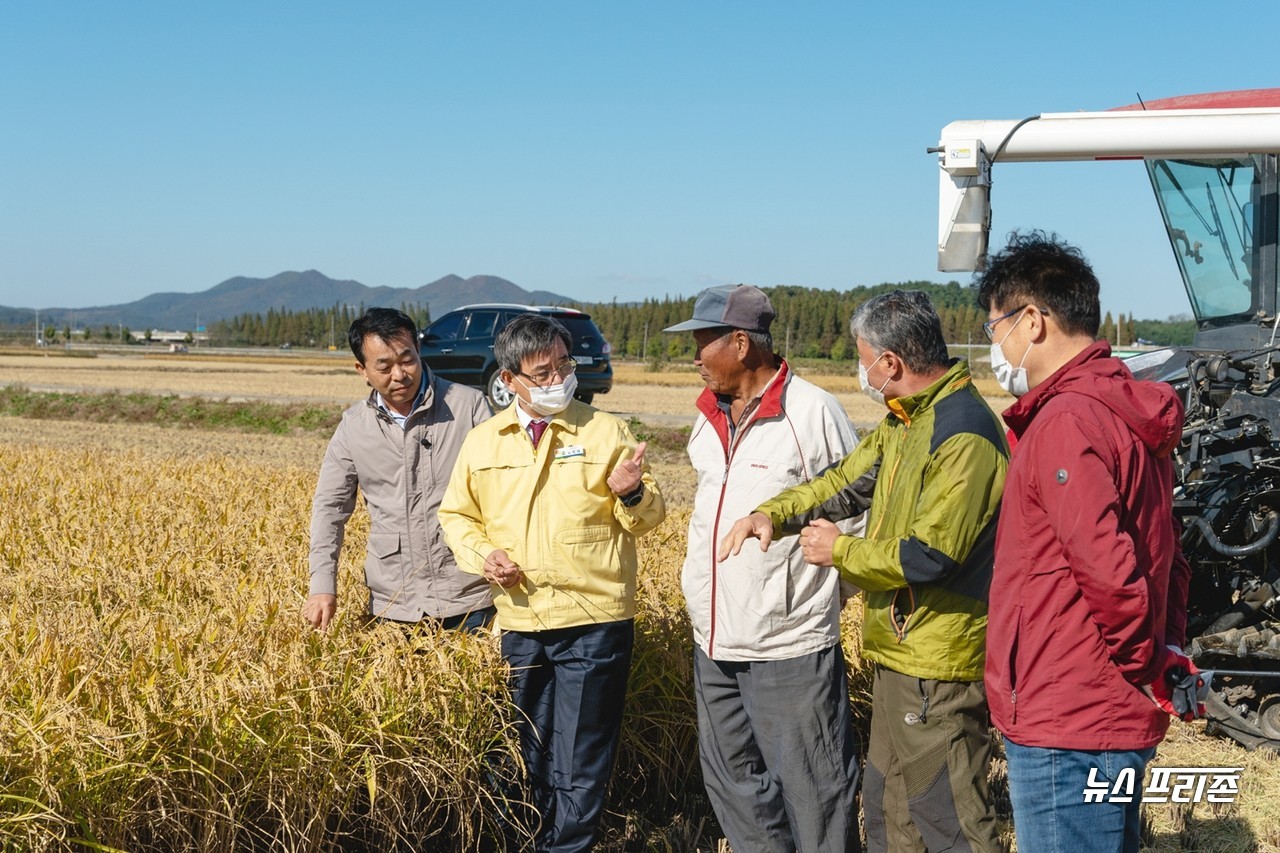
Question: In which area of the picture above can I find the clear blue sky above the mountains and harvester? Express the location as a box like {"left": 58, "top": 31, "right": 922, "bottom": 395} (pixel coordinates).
{"left": 0, "top": 0, "right": 1280, "bottom": 319}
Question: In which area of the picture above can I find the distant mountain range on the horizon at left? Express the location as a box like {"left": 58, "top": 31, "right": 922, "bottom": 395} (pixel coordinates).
{"left": 0, "top": 269, "right": 573, "bottom": 332}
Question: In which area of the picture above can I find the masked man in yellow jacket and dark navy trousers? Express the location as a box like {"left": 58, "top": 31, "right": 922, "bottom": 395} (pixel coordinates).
{"left": 439, "top": 314, "right": 666, "bottom": 853}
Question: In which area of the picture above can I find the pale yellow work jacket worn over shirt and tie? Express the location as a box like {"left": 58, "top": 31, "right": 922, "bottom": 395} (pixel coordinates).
{"left": 439, "top": 400, "right": 666, "bottom": 631}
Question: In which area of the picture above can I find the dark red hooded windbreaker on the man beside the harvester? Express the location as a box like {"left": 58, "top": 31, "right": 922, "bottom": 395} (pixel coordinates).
{"left": 986, "top": 342, "right": 1190, "bottom": 749}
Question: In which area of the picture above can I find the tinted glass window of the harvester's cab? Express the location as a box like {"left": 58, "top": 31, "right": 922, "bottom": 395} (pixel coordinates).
{"left": 1147, "top": 156, "right": 1262, "bottom": 325}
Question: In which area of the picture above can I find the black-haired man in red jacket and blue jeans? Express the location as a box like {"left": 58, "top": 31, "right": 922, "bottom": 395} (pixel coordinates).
{"left": 977, "top": 232, "right": 1194, "bottom": 853}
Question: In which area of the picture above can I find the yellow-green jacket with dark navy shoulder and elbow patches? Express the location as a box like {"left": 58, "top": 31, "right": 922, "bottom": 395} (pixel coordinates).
{"left": 756, "top": 361, "right": 1009, "bottom": 681}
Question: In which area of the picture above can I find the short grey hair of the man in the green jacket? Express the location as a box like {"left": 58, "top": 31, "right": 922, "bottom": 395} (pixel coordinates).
{"left": 849, "top": 291, "right": 950, "bottom": 373}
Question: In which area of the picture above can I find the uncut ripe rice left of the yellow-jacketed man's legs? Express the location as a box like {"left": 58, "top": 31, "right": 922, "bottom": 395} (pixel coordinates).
{"left": 0, "top": 444, "right": 529, "bottom": 850}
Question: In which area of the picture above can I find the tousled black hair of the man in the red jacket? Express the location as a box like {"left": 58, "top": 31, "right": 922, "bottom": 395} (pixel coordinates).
{"left": 973, "top": 231, "right": 1102, "bottom": 338}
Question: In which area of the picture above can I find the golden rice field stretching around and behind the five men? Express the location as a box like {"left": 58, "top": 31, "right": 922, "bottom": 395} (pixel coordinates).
{"left": 0, "top": 356, "right": 1280, "bottom": 852}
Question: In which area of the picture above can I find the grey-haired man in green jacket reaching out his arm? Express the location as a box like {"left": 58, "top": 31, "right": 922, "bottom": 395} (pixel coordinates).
{"left": 719, "top": 291, "right": 1009, "bottom": 852}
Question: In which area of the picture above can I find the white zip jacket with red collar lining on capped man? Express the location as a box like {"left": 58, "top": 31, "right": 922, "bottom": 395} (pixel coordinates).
{"left": 682, "top": 361, "right": 858, "bottom": 661}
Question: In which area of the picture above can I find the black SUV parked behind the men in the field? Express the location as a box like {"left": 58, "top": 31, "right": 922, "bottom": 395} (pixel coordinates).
{"left": 421, "top": 304, "right": 613, "bottom": 409}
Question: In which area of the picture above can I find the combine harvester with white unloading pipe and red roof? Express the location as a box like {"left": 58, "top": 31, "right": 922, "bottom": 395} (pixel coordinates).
{"left": 929, "top": 88, "right": 1280, "bottom": 751}
